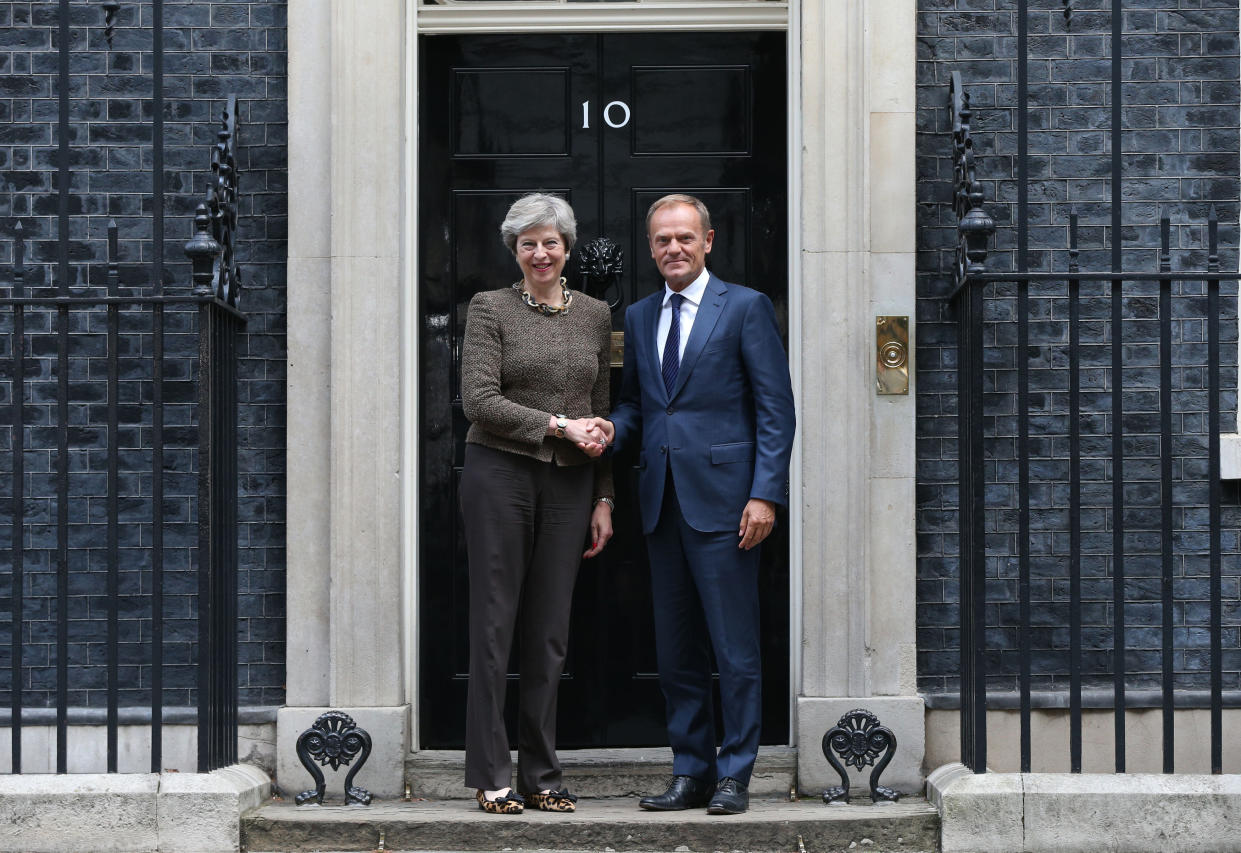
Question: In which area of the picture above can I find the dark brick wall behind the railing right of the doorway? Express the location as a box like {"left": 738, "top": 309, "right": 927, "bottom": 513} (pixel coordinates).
{"left": 916, "top": 0, "right": 1241, "bottom": 693}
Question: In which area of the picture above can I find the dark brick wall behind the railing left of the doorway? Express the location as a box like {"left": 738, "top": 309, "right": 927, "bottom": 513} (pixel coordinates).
{"left": 0, "top": 0, "right": 288, "bottom": 705}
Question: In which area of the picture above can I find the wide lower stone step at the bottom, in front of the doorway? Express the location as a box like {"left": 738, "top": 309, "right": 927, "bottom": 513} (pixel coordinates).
{"left": 241, "top": 795, "right": 939, "bottom": 853}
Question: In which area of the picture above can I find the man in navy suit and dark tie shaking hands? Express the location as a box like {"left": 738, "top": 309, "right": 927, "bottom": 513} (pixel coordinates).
{"left": 601, "top": 195, "right": 795, "bottom": 815}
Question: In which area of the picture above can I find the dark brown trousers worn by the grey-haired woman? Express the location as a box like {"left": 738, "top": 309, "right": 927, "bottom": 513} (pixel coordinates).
{"left": 460, "top": 445, "right": 593, "bottom": 792}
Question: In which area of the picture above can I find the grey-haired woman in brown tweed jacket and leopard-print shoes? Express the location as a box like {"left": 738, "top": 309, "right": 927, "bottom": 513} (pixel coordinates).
{"left": 460, "top": 194, "right": 612, "bottom": 815}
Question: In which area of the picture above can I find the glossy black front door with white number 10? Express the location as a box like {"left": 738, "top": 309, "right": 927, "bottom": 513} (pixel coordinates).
{"left": 418, "top": 32, "right": 789, "bottom": 749}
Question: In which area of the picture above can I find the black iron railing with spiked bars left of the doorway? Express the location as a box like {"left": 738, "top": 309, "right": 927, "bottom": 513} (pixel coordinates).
{"left": 0, "top": 93, "right": 244, "bottom": 772}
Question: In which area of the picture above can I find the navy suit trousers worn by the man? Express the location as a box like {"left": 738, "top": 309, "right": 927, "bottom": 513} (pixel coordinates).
{"left": 647, "top": 472, "right": 762, "bottom": 785}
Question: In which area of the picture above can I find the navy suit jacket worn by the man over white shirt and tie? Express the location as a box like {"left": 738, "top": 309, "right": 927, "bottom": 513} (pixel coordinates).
{"left": 611, "top": 274, "right": 795, "bottom": 533}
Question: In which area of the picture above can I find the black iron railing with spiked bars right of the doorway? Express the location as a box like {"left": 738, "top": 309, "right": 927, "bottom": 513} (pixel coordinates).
{"left": 952, "top": 65, "right": 1241, "bottom": 774}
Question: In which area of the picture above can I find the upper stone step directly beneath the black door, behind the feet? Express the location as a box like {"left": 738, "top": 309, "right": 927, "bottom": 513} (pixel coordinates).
{"left": 402, "top": 746, "right": 799, "bottom": 800}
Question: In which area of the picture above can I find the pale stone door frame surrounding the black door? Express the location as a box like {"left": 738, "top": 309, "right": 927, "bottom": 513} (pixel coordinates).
{"left": 278, "top": 0, "right": 923, "bottom": 796}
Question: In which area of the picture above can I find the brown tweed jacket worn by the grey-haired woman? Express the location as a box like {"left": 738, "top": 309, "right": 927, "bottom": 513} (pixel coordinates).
{"left": 460, "top": 287, "right": 613, "bottom": 498}
